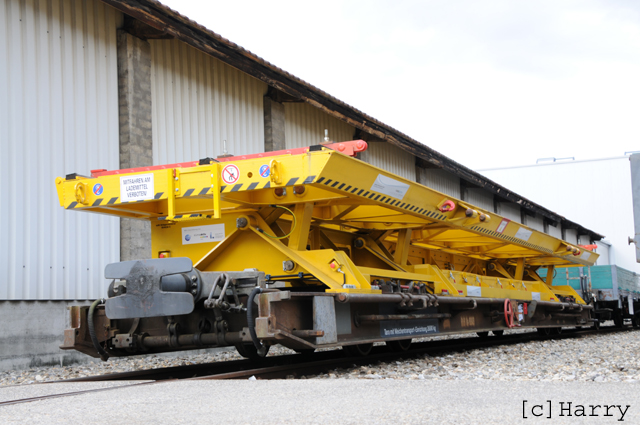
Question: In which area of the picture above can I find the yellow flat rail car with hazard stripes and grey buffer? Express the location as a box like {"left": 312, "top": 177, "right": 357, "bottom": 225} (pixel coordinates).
{"left": 56, "top": 140, "right": 598, "bottom": 359}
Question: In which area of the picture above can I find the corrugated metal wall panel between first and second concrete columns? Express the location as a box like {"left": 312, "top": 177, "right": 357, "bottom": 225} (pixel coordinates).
{"left": 149, "top": 40, "right": 267, "bottom": 164}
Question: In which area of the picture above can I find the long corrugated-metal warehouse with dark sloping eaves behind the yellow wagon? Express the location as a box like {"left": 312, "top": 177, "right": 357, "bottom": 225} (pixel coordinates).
{"left": 0, "top": 0, "right": 602, "bottom": 369}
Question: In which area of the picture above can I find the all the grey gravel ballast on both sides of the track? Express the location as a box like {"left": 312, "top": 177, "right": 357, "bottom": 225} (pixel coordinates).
{"left": 0, "top": 330, "right": 640, "bottom": 386}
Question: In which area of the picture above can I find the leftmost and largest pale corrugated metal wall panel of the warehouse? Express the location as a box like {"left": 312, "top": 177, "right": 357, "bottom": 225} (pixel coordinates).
{"left": 0, "top": 0, "right": 122, "bottom": 300}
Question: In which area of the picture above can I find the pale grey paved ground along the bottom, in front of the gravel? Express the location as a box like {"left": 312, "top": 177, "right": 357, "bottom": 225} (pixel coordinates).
{"left": 0, "top": 380, "right": 640, "bottom": 425}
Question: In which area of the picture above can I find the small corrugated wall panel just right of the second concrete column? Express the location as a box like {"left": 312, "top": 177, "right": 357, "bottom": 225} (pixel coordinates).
{"left": 284, "top": 103, "right": 355, "bottom": 149}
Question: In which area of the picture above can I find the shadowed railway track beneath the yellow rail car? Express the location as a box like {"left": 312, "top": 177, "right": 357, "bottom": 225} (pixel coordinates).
{"left": 0, "top": 327, "right": 631, "bottom": 407}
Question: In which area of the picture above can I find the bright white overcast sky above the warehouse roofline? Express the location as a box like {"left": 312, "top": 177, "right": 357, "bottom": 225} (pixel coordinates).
{"left": 161, "top": 0, "right": 640, "bottom": 169}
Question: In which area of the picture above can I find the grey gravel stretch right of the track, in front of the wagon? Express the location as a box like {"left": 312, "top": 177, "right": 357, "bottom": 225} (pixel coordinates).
{"left": 315, "top": 331, "right": 640, "bottom": 382}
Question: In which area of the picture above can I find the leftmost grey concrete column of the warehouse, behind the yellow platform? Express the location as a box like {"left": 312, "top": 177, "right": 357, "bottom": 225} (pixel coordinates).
{"left": 117, "top": 30, "right": 153, "bottom": 261}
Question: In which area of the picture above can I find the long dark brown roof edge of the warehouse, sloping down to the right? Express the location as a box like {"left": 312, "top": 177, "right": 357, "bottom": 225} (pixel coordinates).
{"left": 102, "top": 0, "right": 604, "bottom": 240}
